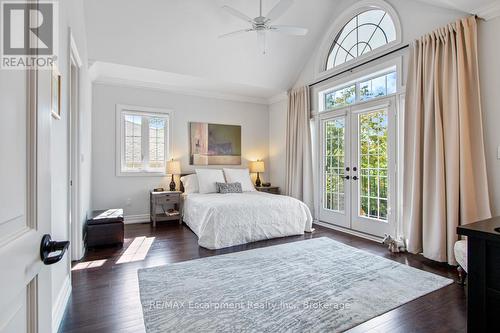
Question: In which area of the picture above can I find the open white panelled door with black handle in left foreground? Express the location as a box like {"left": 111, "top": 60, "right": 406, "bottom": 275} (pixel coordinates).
{"left": 0, "top": 55, "right": 52, "bottom": 333}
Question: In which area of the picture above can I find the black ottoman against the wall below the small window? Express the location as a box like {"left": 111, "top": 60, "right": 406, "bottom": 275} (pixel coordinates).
{"left": 87, "top": 209, "right": 124, "bottom": 247}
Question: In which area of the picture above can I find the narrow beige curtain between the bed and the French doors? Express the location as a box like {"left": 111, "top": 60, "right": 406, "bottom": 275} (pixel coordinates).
{"left": 285, "top": 87, "right": 314, "bottom": 211}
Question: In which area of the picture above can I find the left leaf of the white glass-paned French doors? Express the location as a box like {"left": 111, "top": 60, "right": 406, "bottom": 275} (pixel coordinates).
{"left": 319, "top": 109, "right": 351, "bottom": 228}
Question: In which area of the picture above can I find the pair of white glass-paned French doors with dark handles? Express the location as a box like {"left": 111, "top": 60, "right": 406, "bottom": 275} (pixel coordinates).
{"left": 319, "top": 98, "right": 397, "bottom": 236}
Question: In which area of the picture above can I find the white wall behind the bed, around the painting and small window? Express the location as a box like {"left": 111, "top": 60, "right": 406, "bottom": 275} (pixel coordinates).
{"left": 92, "top": 83, "right": 269, "bottom": 216}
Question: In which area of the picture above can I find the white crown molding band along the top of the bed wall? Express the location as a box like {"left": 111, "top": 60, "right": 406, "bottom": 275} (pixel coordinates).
{"left": 89, "top": 61, "right": 280, "bottom": 105}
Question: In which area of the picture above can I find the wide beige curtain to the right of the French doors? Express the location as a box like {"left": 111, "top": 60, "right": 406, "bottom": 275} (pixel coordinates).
{"left": 403, "top": 17, "right": 491, "bottom": 264}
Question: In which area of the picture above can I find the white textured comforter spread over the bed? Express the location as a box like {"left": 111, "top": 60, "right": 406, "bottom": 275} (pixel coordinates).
{"left": 183, "top": 192, "right": 312, "bottom": 249}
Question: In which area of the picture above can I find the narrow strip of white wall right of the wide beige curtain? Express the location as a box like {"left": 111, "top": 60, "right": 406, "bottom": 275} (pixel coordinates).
{"left": 479, "top": 17, "right": 500, "bottom": 216}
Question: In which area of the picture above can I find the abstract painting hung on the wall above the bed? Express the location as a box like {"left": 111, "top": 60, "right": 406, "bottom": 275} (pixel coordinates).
{"left": 189, "top": 123, "right": 241, "bottom": 165}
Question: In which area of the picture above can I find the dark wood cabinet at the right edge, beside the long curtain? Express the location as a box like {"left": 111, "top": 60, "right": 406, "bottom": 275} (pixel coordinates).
{"left": 457, "top": 217, "right": 500, "bottom": 332}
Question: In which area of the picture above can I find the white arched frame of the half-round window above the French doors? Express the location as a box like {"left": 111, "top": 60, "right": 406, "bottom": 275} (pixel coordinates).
{"left": 315, "top": 0, "right": 403, "bottom": 80}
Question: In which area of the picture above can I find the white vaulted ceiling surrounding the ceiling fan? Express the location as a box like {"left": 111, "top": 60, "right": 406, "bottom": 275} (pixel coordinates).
{"left": 84, "top": 0, "right": 498, "bottom": 98}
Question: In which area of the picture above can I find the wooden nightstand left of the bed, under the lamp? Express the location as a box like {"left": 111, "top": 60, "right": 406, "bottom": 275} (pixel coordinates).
{"left": 149, "top": 191, "right": 182, "bottom": 227}
